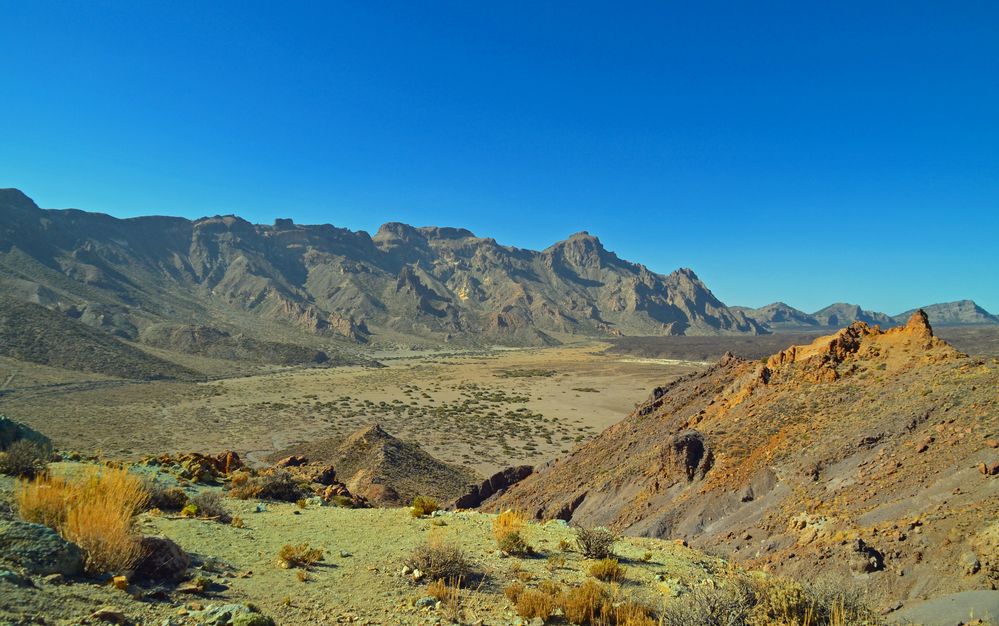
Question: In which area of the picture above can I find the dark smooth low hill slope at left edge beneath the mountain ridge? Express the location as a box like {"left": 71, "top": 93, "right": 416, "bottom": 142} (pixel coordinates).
{"left": 0, "top": 298, "right": 198, "bottom": 380}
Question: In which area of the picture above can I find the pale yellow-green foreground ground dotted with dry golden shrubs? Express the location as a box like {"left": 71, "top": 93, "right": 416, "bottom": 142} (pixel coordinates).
{"left": 0, "top": 463, "right": 876, "bottom": 626}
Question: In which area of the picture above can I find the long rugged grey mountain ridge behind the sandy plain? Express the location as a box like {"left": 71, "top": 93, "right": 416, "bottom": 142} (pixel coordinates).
{"left": 0, "top": 189, "right": 763, "bottom": 349}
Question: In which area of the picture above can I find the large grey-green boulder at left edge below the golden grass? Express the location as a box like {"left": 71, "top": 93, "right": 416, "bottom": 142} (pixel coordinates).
{"left": 0, "top": 520, "right": 83, "bottom": 576}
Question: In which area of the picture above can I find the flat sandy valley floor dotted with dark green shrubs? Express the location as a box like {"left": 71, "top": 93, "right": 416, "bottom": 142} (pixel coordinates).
{"left": 0, "top": 344, "right": 701, "bottom": 475}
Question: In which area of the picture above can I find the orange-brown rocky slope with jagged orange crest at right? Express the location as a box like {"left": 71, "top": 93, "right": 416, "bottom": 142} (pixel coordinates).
{"left": 490, "top": 311, "right": 999, "bottom": 599}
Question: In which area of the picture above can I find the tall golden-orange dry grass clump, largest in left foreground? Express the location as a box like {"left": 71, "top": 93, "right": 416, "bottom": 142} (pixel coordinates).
{"left": 15, "top": 468, "right": 149, "bottom": 575}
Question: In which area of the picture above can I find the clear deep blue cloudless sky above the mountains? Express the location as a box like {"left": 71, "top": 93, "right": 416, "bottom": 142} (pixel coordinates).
{"left": 0, "top": 0, "right": 999, "bottom": 313}
